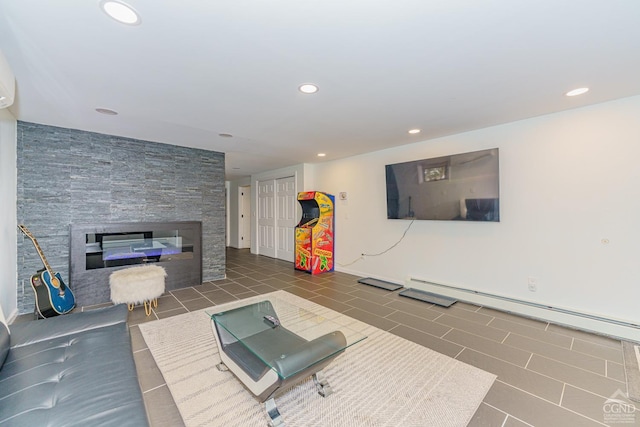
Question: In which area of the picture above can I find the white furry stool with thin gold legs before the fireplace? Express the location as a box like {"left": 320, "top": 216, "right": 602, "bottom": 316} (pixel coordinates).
{"left": 109, "top": 265, "right": 167, "bottom": 316}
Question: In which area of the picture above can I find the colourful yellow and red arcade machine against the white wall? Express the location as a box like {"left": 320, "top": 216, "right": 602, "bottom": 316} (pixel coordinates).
{"left": 295, "top": 191, "right": 335, "bottom": 274}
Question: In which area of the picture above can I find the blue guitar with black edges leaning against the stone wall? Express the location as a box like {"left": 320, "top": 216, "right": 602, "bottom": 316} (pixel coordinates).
{"left": 18, "top": 225, "right": 76, "bottom": 318}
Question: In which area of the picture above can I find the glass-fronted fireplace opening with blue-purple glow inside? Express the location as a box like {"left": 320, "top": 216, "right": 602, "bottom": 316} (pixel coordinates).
{"left": 85, "top": 230, "right": 193, "bottom": 270}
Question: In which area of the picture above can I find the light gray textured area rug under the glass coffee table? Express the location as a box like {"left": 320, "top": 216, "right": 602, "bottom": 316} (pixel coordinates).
{"left": 140, "top": 291, "right": 495, "bottom": 427}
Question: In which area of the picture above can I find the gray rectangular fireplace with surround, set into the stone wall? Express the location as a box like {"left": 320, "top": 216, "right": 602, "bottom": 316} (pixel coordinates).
{"left": 69, "top": 221, "right": 202, "bottom": 306}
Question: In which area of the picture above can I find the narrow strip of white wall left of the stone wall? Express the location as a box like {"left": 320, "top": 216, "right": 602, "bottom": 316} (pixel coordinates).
{"left": 0, "top": 109, "right": 18, "bottom": 319}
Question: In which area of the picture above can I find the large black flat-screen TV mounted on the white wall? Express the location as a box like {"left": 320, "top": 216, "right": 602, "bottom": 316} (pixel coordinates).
{"left": 386, "top": 148, "right": 500, "bottom": 222}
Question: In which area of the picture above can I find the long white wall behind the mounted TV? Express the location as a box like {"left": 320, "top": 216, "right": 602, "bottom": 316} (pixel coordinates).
{"left": 308, "top": 97, "right": 640, "bottom": 323}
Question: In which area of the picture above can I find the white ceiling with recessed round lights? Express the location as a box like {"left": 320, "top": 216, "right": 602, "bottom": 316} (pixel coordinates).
{"left": 0, "top": 0, "right": 640, "bottom": 179}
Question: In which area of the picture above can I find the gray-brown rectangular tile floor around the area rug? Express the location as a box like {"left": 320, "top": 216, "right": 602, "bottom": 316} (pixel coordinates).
{"left": 105, "top": 249, "right": 640, "bottom": 427}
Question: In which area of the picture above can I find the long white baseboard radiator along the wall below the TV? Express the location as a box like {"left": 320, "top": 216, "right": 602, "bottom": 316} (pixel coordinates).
{"left": 405, "top": 277, "right": 640, "bottom": 342}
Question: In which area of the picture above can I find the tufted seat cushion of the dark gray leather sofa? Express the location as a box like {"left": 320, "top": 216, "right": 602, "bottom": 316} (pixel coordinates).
{"left": 0, "top": 324, "right": 147, "bottom": 426}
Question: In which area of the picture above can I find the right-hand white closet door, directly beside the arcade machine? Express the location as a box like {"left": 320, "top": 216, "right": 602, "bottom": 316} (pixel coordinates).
{"left": 276, "top": 176, "right": 298, "bottom": 262}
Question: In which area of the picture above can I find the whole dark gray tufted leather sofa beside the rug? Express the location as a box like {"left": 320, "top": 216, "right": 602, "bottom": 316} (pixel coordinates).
{"left": 0, "top": 304, "right": 148, "bottom": 427}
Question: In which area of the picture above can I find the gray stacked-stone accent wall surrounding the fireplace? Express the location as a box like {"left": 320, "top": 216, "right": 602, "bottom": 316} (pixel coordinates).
{"left": 17, "top": 122, "right": 226, "bottom": 313}
